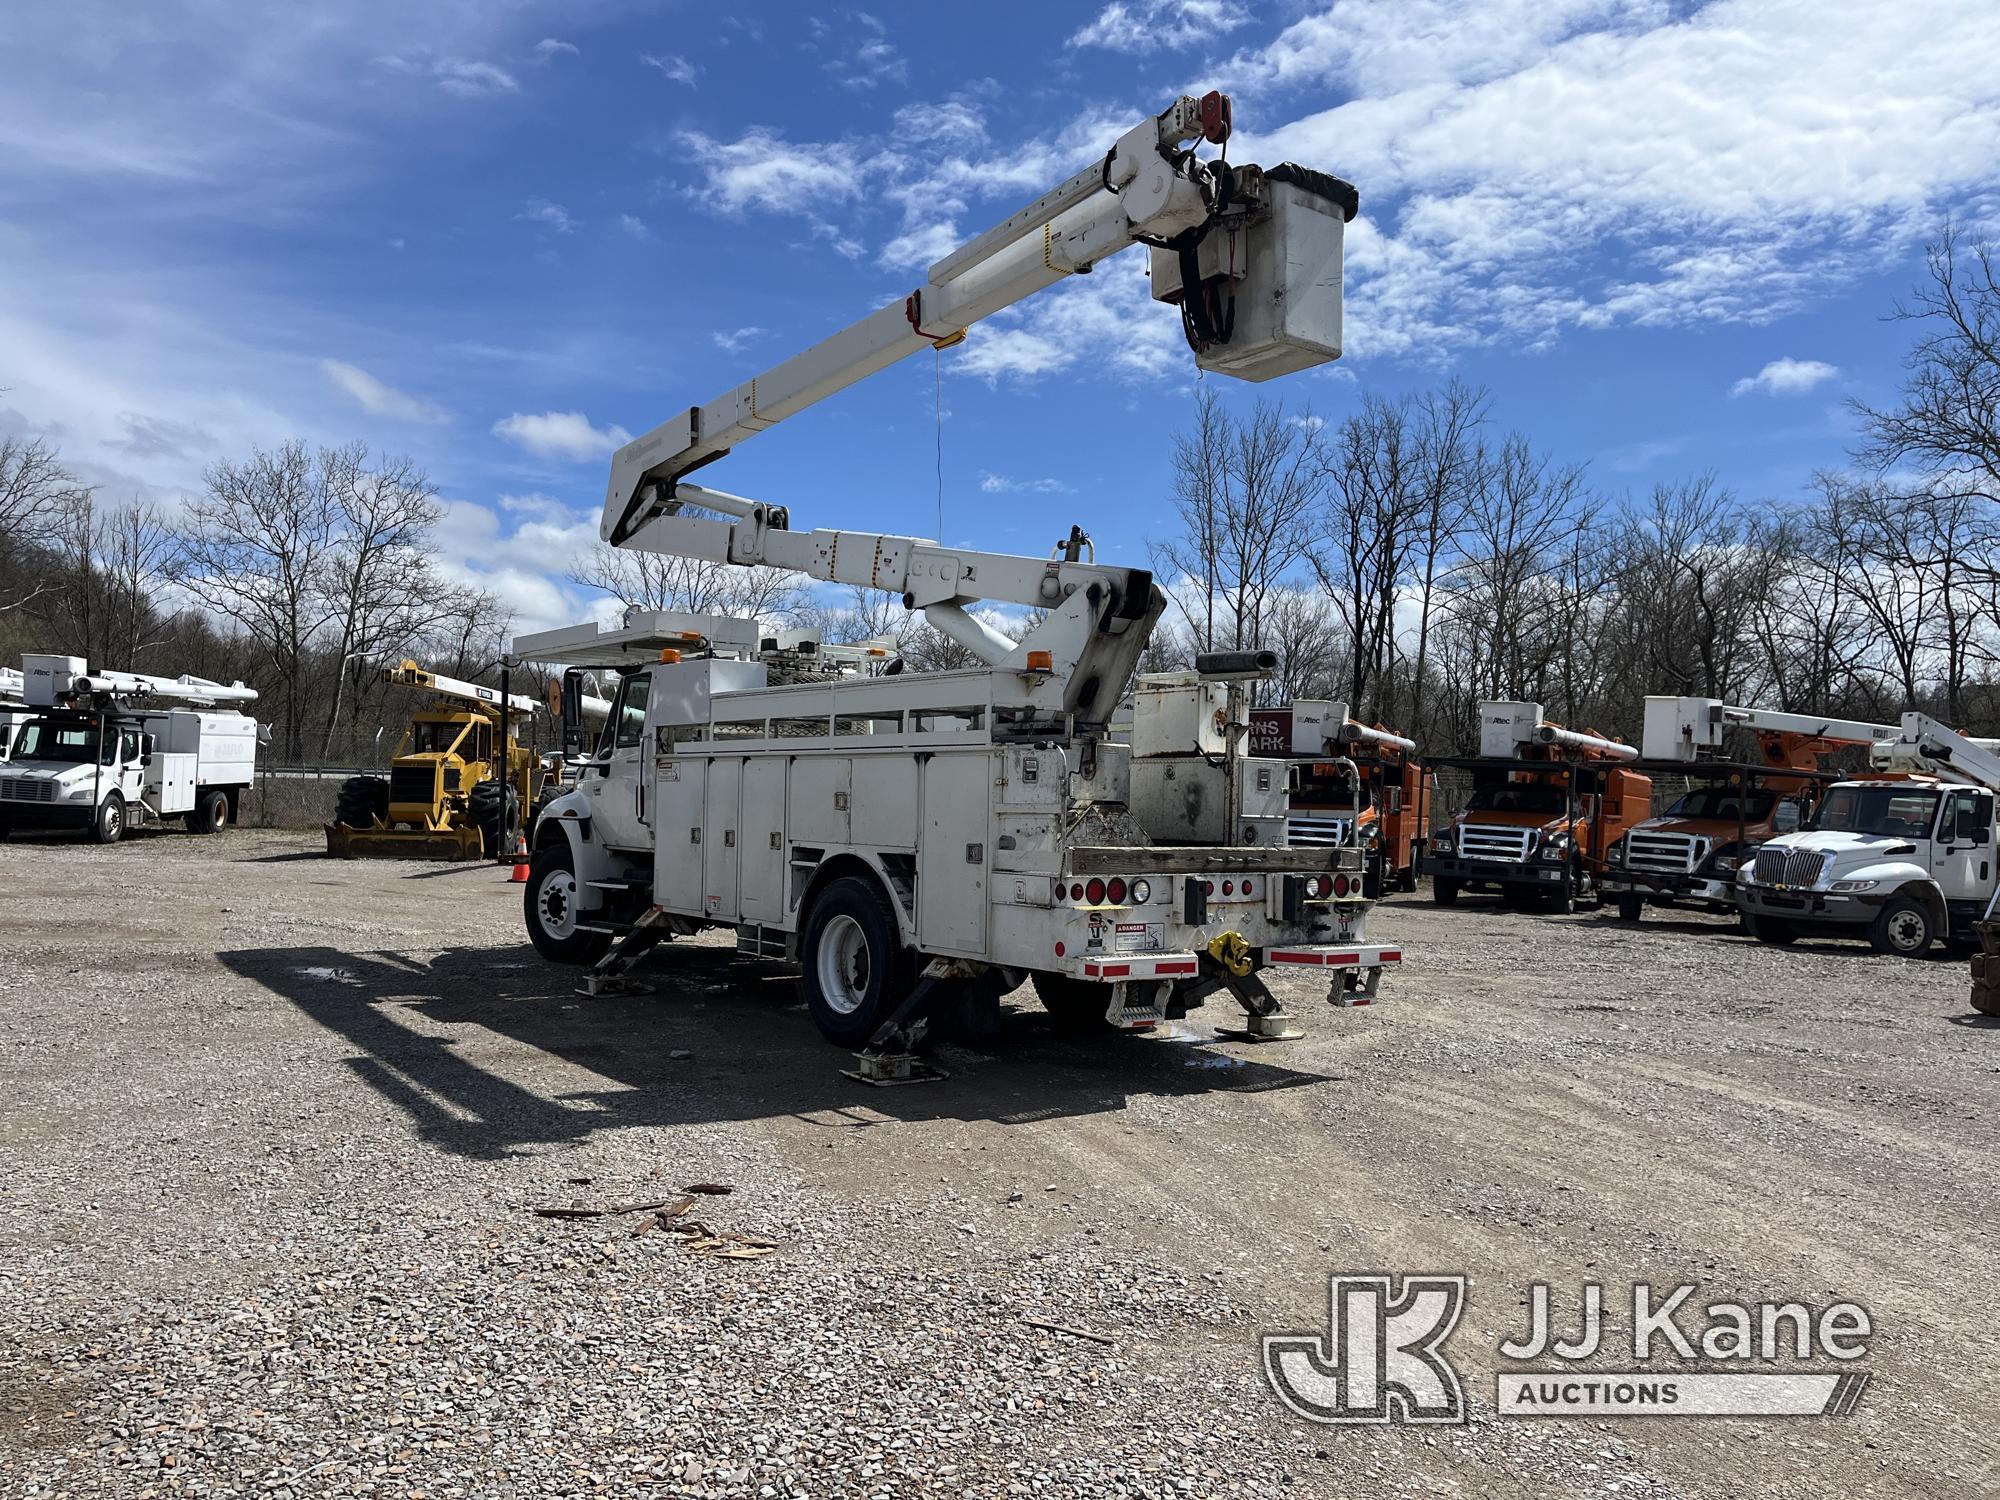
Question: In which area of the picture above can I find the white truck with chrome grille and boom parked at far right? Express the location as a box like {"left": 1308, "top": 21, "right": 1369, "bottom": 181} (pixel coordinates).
{"left": 1736, "top": 712, "right": 2000, "bottom": 958}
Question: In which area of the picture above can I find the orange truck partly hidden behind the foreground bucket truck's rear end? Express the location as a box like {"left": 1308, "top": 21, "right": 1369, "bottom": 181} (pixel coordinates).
{"left": 1250, "top": 698, "right": 1436, "bottom": 898}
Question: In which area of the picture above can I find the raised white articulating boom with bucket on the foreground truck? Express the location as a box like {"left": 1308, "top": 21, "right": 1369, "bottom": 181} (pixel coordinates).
{"left": 602, "top": 94, "right": 1356, "bottom": 724}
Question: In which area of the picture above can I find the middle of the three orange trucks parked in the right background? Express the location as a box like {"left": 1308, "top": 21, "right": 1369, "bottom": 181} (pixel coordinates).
{"left": 1420, "top": 702, "right": 1652, "bottom": 912}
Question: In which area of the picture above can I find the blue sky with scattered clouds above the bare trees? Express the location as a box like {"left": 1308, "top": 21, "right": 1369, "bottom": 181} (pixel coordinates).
{"left": 0, "top": 0, "right": 2000, "bottom": 628}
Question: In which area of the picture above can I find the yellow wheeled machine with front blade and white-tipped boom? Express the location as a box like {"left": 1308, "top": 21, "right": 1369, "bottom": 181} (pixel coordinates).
{"left": 326, "top": 662, "right": 542, "bottom": 860}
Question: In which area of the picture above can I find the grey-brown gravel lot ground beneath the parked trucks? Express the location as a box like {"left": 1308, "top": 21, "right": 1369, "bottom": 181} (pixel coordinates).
{"left": 0, "top": 830, "right": 2000, "bottom": 1500}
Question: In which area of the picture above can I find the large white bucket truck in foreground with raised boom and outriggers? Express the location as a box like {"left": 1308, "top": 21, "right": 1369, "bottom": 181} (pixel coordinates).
{"left": 516, "top": 94, "right": 1400, "bottom": 1074}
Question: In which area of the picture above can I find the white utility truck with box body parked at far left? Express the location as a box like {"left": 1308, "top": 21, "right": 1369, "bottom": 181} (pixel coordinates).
{"left": 0, "top": 656, "right": 258, "bottom": 844}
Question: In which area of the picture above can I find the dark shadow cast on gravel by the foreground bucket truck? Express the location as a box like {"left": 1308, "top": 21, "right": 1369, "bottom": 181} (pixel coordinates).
{"left": 218, "top": 944, "right": 1332, "bottom": 1158}
